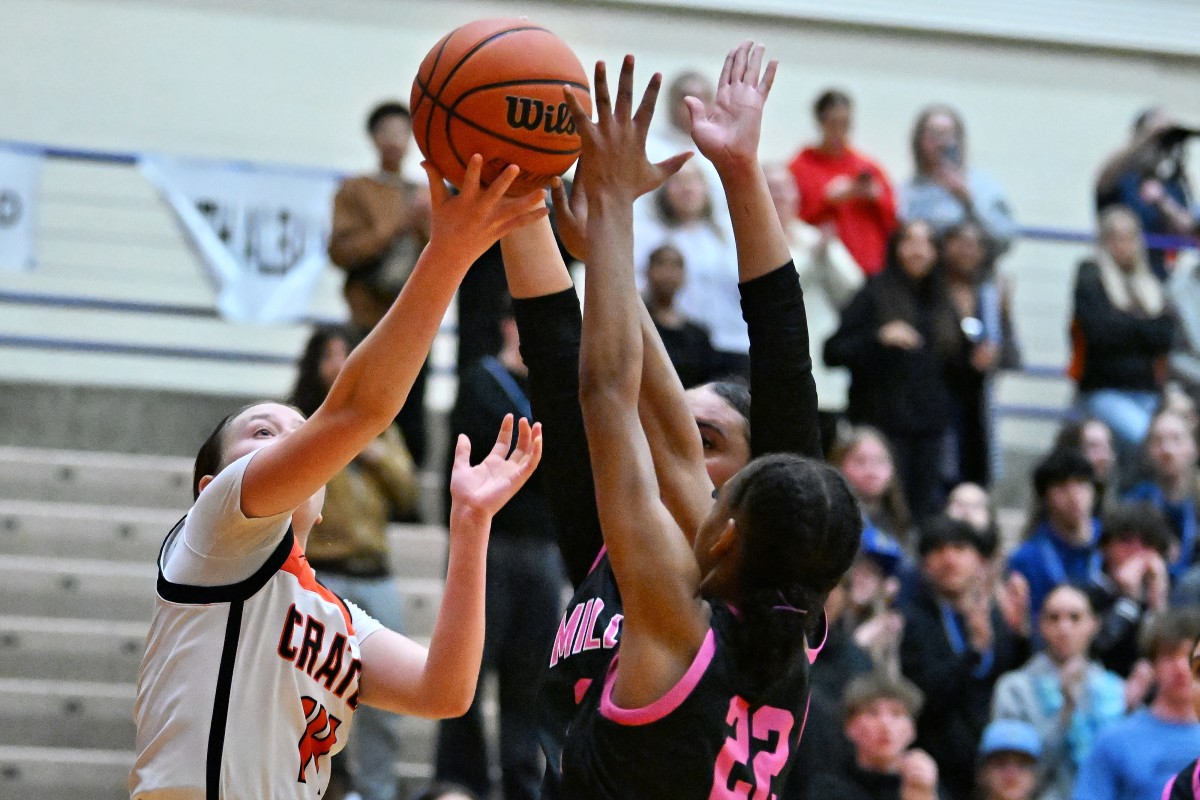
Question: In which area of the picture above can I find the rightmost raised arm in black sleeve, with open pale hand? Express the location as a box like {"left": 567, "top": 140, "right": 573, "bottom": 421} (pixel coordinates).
{"left": 686, "top": 42, "right": 822, "bottom": 458}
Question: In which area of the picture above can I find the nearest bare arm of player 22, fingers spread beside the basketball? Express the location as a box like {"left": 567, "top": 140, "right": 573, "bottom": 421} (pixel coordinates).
{"left": 565, "top": 56, "right": 708, "bottom": 708}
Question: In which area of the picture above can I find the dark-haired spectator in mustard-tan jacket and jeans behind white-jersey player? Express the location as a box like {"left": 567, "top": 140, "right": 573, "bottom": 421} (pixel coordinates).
{"left": 290, "top": 326, "right": 420, "bottom": 800}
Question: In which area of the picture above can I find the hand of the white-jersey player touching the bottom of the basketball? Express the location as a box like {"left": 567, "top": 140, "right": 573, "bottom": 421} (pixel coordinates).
{"left": 421, "top": 154, "right": 550, "bottom": 264}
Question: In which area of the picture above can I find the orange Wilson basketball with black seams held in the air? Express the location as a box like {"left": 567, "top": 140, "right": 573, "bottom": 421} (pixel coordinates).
{"left": 409, "top": 19, "right": 592, "bottom": 196}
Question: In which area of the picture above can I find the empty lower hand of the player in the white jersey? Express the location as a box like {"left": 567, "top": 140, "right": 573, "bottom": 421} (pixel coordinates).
{"left": 450, "top": 414, "right": 541, "bottom": 517}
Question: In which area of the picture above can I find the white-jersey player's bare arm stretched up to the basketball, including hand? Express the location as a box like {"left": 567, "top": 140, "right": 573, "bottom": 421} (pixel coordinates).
{"left": 241, "top": 156, "right": 546, "bottom": 517}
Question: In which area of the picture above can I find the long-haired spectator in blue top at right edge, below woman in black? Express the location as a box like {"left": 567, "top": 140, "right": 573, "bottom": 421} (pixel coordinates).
{"left": 1126, "top": 409, "right": 1200, "bottom": 578}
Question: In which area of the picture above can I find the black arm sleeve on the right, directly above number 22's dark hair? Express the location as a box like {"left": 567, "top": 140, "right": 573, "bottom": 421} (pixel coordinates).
{"left": 738, "top": 261, "right": 822, "bottom": 458}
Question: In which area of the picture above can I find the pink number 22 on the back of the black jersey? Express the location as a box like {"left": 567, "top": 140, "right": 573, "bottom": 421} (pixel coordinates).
{"left": 708, "top": 697, "right": 796, "bottom": 800}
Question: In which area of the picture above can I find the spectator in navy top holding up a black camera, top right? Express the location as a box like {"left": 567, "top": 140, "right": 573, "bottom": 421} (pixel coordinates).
{"left": 1096, "top": 108, "right": 1200, "bottom": 278}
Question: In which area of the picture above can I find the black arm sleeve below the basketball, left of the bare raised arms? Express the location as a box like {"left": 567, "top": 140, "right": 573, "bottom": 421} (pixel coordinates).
{"left": 512, "top": 288, "right": 604, "bottom": 587}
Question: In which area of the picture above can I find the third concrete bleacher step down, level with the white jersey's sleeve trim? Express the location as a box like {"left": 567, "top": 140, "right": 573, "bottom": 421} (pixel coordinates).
{"left": 0, "top": 555, "right": 442, "bottom": 637}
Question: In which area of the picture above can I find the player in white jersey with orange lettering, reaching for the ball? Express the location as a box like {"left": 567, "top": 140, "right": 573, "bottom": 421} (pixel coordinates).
{"left": 130, "top": 156, "right": 546, "bottom": 800}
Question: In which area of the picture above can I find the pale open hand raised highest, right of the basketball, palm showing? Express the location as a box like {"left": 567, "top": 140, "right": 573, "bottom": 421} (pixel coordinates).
{"left": 684, "top": 41, "right": 779, "bottom": 173}
